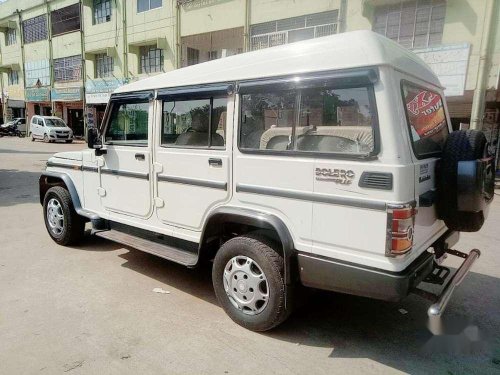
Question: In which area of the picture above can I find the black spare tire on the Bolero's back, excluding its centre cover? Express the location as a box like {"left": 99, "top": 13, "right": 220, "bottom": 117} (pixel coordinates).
{"left": 437, "top": 130, "right": 487, "bottom": 232}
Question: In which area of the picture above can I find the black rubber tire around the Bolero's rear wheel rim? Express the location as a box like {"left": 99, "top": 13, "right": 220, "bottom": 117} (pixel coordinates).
{"left": 212, "top": 234, "right": 291, "bottom": 332}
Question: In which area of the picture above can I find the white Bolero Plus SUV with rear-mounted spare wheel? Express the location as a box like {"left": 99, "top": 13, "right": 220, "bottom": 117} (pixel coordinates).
{"left": 40, "top": 31, "right": 493, "bottom": 331}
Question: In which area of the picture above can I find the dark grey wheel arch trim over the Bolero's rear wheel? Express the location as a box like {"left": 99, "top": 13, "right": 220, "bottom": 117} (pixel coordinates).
{"left": 199, "top": 207, "right": 298, "bottom": 284}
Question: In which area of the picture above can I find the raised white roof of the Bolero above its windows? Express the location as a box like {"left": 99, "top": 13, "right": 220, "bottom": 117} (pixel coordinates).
{"left": 115, "top": 30, "right": 441, "bottom": 93}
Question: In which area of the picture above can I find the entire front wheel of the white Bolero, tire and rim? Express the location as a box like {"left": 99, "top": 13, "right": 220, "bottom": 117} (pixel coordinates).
{"left": 43, "top": 186, "right": 85, "bottom": 246}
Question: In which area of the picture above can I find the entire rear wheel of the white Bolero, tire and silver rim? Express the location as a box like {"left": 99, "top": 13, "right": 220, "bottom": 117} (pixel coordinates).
{"left": 212, "top": 234, "right": 289, "bottom": 332}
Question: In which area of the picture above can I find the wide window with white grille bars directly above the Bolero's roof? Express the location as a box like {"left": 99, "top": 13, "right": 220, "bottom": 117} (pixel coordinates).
{"left": 250, "top": 10, "right": 339, "bottom": 50}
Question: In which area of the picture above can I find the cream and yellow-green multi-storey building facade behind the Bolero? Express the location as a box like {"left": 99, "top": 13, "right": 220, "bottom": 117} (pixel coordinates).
{"left": 0, "top": 0, "right": 500, "bottom": 136}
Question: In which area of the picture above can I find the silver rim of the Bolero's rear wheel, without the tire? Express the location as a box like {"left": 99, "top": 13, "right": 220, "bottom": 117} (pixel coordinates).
{"left": 223, "top": 256, "right": 269, "bottom": 315}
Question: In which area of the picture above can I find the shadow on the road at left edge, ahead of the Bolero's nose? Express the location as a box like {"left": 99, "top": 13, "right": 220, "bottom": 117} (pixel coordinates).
{"left": 0, "top": 169, "right": 40, "bottom": 207}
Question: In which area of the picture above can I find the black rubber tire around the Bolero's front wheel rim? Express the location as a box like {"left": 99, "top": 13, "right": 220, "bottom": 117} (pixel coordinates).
{"left": 43, "top": 186, "right": 85, "bottom": 246}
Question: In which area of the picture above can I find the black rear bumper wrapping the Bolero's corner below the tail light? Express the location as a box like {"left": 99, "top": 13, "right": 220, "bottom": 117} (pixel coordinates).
{"left": 298, "top": 252, "right": 434, "bottom": 301}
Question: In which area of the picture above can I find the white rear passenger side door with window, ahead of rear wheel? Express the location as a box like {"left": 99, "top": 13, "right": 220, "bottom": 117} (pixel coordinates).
{"left": 154, "top": 85, "right": 234, "bottom": 231}
